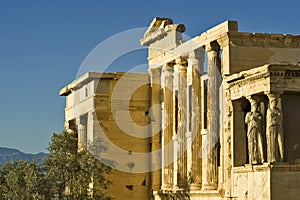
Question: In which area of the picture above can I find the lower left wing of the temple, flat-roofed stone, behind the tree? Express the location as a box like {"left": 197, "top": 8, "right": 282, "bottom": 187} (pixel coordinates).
{"left": 62, "top": 73, "right": 151, "bottom": 200}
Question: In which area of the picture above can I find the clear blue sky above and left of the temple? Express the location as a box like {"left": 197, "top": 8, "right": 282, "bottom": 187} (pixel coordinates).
{"left": 0, "top": 0, "right": 300, "bottom": 152}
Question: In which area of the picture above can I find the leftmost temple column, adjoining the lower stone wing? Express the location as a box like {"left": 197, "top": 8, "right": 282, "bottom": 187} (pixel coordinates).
{"left": 149, "top": 68, "right": 162, "bottom": 191}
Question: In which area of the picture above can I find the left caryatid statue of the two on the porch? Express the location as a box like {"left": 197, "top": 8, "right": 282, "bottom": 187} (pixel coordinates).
{"left": 245, "top": 98, "right": 264, "bottom": 164}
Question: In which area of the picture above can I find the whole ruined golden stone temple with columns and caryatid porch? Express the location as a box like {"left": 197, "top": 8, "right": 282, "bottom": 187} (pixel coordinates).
{"left": 61, "top": 18, "right": 300, "bottom": 200}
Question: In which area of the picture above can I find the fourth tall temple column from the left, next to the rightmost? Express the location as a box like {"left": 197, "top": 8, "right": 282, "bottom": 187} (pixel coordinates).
{"left": 188, "top": 48, "right": 204, "bottom": 190}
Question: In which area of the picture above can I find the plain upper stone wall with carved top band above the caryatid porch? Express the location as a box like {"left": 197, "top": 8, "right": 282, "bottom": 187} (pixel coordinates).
{"left": 228, "top": 32, "right": 300, "bottom": 74}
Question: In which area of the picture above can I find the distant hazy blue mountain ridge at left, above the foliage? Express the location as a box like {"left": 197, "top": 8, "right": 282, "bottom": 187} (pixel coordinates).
{"left": 0, "top": 147, "right": 47, "bottom": 165}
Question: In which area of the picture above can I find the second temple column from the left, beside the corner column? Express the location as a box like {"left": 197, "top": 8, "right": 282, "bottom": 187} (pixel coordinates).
{"left": 162, "top": 64, "right": 174, "bottom": 189}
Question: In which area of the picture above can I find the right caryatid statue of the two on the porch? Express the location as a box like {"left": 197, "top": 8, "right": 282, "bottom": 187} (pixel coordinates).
{"left": 267, "top": 94, "right": 284, "bottom": 163}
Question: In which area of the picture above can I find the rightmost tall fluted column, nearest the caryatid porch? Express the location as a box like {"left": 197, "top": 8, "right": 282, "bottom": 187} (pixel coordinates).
{"left": 202, "top": 43, "right": 221, "bottom": 190}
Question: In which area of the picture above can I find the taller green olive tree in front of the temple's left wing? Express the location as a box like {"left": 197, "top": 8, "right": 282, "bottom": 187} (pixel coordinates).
{"left": 44, "top": 131, "right": 111, "bottom": 200}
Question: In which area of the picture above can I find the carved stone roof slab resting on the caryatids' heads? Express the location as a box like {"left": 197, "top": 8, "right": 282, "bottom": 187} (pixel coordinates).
{"left": 224, "top": 64, "right": 300, "bottom": 100}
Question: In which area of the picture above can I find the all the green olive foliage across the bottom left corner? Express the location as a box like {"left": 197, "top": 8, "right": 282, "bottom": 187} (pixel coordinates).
{"left": 0, "top": 131, "right": 111, "bottom": 200}
